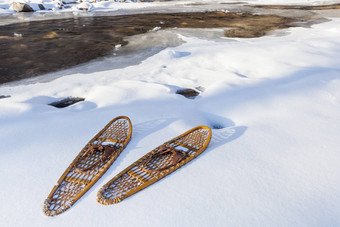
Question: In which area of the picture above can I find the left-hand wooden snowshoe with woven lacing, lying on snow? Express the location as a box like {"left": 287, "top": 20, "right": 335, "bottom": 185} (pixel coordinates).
{"left": 43, "top": 116, "right": 132, "bottom": 216}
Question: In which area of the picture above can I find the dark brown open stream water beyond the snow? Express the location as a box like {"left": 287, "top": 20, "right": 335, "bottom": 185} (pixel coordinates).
{"left": 0, "top": 12, "right": 294, "bottom": 84}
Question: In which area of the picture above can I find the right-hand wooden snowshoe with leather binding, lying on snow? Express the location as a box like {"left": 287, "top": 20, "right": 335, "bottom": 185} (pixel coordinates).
{"left": 97, "top": 126, "right": 211, "bottom": 205}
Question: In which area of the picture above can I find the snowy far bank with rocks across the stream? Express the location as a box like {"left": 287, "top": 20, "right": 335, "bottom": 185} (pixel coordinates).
{"left": 0, "top": 0, "right": 340, "bottom": 15}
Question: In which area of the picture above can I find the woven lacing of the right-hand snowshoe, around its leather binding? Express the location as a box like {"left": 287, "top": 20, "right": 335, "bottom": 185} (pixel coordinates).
{"left": 97, "top": 129, "right": 209, "bottom": 205}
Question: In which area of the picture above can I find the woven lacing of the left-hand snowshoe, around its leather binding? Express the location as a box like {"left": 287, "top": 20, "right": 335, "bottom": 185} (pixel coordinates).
{"left": 44, "top": 119, "right": 130, "bottom": 216}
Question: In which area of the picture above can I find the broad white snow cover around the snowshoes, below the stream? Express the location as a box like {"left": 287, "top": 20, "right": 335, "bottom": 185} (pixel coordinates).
{"left": 0, "top": 0, "right": 340, "bottom": 226}
